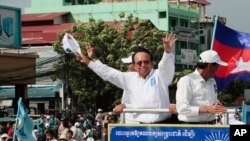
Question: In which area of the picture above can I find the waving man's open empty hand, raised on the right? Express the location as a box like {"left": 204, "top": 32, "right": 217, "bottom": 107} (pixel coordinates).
{"left": 163, "top": 32, "right": 177, "bottom": 53}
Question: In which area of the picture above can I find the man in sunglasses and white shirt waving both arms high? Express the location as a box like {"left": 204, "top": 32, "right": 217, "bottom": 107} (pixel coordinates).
{"left": 77, "top": 33, "right": 176, "bottom": 123}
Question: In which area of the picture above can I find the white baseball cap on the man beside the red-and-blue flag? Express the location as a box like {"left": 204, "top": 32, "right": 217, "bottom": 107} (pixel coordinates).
{"left": 199, "top": 50, "right": 228, "bottom": 66}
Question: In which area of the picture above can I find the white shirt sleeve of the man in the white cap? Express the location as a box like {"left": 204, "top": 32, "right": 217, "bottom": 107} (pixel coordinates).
{"left": 176, "top": 77, "right": 199, "bottom": 116}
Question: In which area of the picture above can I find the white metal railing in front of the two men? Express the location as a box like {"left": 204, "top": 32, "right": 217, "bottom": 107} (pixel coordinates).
{"left": 120, "top": 108, "right": 235, "bottom": 125}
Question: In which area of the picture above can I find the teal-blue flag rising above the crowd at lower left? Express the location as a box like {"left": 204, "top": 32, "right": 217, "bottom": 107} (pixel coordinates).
{"left": 14, "top": 98, "right": 36, "bottom": 141}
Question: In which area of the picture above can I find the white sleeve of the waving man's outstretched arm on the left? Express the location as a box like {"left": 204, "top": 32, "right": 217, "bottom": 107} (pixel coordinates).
{"left": 88, "top": 60, "right": 124, "bottom": 89}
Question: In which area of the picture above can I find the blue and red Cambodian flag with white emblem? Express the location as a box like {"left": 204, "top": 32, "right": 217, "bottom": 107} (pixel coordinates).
{"left": 212, "top": 22, "right": 250, "bottom": 91}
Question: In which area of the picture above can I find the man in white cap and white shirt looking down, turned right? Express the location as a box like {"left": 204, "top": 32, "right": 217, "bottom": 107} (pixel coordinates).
{"left": 176, "top": 50, "right": 228, "bottom": 124}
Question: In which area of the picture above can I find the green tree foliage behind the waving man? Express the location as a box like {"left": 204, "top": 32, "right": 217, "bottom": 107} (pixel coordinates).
{"left": 53, "top": 15, "right": 165, "bottom": 112}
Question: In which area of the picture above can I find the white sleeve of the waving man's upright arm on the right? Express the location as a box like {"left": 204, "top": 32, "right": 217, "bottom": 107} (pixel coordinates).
{"left": 158, "top": 51, "right": 175, "bottom": 86}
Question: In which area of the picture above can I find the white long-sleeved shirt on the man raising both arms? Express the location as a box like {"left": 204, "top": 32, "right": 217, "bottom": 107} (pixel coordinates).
{"left": 88, "top": 52, "right": 175, "bottom": 123}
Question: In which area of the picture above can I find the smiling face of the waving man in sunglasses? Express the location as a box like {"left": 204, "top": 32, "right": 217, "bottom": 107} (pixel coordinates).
{"left": 134, "top": 52, "right": 152, "bottom": 78}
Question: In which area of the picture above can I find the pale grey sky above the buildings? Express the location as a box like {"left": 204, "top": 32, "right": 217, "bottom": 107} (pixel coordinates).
{"left": 0, "top": 0, "right": 250, "bottom": 33}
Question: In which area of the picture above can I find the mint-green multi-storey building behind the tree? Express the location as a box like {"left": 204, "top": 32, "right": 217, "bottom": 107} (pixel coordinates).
{"left": 24, "top": 0, "right": 207, "bottom": 69}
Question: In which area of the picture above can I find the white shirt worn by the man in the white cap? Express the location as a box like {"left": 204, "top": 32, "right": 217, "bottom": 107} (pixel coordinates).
{"left": 176, "top": 70, "right": 218, "bottom": 122}
